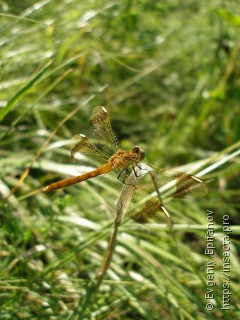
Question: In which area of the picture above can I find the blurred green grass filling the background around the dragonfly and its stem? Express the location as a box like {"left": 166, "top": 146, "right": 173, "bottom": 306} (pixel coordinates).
{"left": 0, "top": 0, "right": 240, "bottom": 320}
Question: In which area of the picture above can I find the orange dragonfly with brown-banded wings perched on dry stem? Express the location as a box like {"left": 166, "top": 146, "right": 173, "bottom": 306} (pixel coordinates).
{"left": 42, "top": 106, "right": 208, "bottom": 224}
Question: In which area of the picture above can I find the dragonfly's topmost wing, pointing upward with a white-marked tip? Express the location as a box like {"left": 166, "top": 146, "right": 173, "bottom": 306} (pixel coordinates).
{"left": 89, "top": 106, "right": 118, "bottom": 157}
